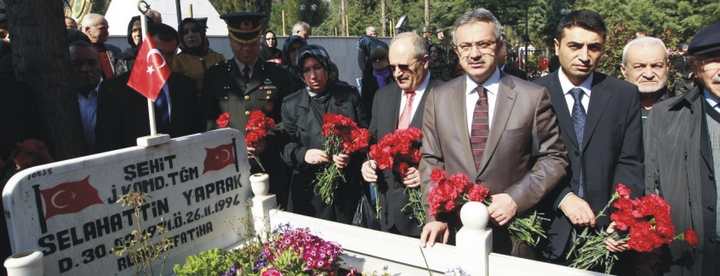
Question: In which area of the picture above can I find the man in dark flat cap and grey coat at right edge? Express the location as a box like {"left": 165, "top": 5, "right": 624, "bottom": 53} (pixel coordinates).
{"left": 645, "top": 22, "right": 720, "bottom": 275}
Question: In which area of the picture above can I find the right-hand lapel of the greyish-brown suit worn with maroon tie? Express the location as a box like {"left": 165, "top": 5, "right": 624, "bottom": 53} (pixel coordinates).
{"left": 478, "top": 77, "right": 517, "bottom": 174}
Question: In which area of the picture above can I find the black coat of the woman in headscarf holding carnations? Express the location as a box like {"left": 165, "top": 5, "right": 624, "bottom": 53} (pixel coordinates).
{"left": 282, "top": 83, "right": 367, "bottom": 223}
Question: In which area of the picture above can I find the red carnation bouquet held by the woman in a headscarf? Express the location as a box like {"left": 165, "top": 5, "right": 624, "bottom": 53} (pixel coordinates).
{"left": 315, "top": 113, "right": 370, "bottom": 205}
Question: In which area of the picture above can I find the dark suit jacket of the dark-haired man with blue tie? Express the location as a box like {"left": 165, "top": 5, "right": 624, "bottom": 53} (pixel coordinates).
{"left": 536, "top": 71, "right": 644, "bottom": 259}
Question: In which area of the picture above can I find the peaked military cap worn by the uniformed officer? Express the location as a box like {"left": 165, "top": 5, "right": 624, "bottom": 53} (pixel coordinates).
{"left": 220, "top": 12, "right": 265, "bottom": 43}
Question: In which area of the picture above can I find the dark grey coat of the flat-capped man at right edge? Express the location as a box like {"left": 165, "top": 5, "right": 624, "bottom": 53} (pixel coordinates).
{"left": 645, "top": 87, "right": 720, "bottom": 276}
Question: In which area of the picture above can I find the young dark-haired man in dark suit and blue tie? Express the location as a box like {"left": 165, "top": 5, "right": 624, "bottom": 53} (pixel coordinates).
{"left": 537, "top": 11, "right": 643, "bottom": 261}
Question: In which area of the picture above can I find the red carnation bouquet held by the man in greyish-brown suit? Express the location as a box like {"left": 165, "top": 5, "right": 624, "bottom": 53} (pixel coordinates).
{"left": 428, "top": 169, "right": 547, "bottom": 246}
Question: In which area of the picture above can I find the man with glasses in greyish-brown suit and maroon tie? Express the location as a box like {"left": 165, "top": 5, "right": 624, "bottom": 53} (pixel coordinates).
{"left": 420, "top": 9, "right": 567, "bottom": 257}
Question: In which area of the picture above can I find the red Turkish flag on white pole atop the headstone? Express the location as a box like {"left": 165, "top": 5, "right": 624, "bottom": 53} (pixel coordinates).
{"left": 128, "top": 35, "right": 171, "bottom": 101}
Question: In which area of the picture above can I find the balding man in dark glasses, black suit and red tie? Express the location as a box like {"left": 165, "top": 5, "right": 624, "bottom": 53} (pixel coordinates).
{"left": 362, "top": 32, "right": 440, "bottom": 237}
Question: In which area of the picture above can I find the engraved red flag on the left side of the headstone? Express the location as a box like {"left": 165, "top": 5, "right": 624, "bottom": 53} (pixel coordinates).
{"left": 40, "top": 176, "right": 103, "bottom": 220}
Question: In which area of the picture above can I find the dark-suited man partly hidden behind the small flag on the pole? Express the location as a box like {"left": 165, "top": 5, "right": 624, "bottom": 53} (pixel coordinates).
{"left": 96, "top": 24, "right": 205, "bottom": 151}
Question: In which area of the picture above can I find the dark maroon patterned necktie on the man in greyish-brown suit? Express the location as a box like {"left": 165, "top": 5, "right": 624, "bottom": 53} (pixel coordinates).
{"left": 470, "top": 86, "right": 490, "bottom": 170}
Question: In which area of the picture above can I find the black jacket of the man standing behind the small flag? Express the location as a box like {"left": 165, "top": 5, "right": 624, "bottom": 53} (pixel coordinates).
{"left": 95, "top": 72, "right": 205, "bottom": 151}
